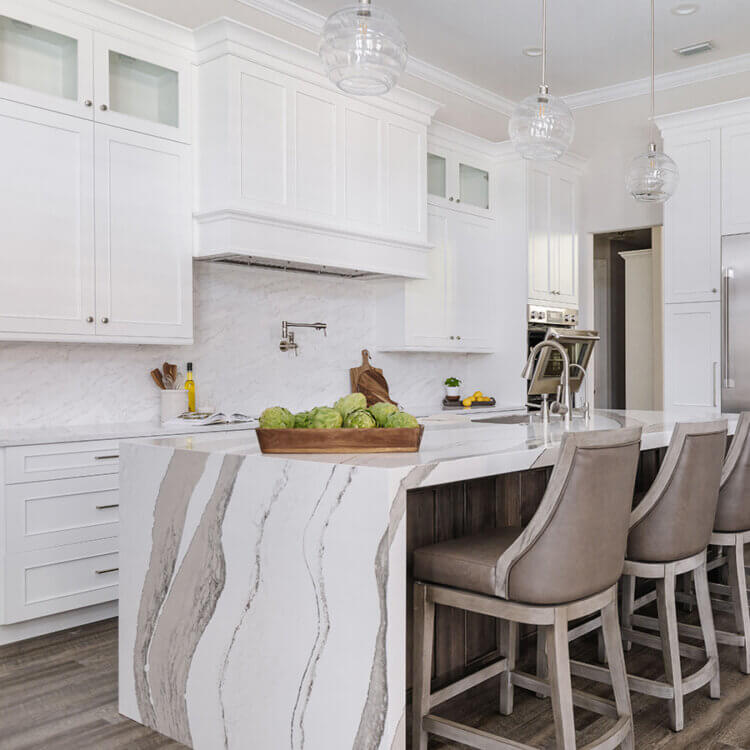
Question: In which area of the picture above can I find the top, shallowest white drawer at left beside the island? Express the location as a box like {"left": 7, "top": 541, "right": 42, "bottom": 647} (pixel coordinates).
{"left": 5, "top": 440, "right": 120, "bottom": 484}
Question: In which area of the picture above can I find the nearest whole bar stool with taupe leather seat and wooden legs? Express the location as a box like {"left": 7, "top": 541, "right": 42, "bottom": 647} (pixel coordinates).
{"left": 412, "top": 427, "right": 641, "bottom": 750}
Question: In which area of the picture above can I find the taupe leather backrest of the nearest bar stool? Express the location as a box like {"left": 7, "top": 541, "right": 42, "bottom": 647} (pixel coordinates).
{"left": 496, "top": 427, "right": 641, "bottom": 604}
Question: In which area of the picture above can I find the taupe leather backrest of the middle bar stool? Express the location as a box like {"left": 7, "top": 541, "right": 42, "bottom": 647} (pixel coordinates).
{"left": 628, "top": 419, "right": 727, "bottom": 562}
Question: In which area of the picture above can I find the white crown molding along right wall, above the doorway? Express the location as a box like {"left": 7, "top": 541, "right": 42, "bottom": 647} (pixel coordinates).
{"left": 563, "top": 54, "right": 750, "bottom": 109}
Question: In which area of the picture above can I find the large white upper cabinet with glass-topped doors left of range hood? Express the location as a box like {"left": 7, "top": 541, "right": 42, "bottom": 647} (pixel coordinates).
{"left": 0, "top": 0, "right": 197, "bottom": 343}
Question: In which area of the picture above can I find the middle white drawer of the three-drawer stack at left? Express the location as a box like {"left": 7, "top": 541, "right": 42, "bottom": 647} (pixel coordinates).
{"left": 5, "top": 474, "right": 119, "bottom": 553}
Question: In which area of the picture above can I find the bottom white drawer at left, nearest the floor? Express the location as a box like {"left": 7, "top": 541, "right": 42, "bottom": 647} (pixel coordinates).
{"left": 3, "top": 538, "right": 119, "bottom": 624}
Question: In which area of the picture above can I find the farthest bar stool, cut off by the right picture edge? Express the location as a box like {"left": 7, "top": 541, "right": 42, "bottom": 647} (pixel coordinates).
{"left": 692, "top": 412, "right": 750, "bottom": 674}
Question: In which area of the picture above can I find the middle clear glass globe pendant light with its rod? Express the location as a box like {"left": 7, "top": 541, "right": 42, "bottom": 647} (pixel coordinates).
{"left": 508, "top": 0, "right": 575, "bottom": 160}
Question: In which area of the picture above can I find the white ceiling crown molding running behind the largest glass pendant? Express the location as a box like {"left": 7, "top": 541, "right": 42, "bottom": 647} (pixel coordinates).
{"left": 237, "top": 0, "right": 516, "bottom": 117}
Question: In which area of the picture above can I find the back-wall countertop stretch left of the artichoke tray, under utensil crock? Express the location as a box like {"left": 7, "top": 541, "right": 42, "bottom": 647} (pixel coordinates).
{"left": 0, "top": 421, "right": 257, "bottom": 448}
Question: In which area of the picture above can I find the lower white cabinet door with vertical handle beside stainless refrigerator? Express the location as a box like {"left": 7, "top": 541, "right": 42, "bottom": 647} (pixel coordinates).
{"left": 664, "top": 301, "right": 721, "bottom": 414}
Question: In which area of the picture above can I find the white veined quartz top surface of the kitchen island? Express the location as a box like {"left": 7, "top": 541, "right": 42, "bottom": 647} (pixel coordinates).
{"left": 128, "top": 410, "right": 737, "bottom": 484}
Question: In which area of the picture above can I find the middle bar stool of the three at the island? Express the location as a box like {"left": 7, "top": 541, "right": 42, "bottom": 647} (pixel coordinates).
{"left": 616, "top": 420, "right": 727, "bottom": 731}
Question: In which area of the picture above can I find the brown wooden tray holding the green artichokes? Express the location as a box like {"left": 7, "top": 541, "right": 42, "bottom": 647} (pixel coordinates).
{"left": 256, "top": 425, "right": 424, "bottom": 453}
